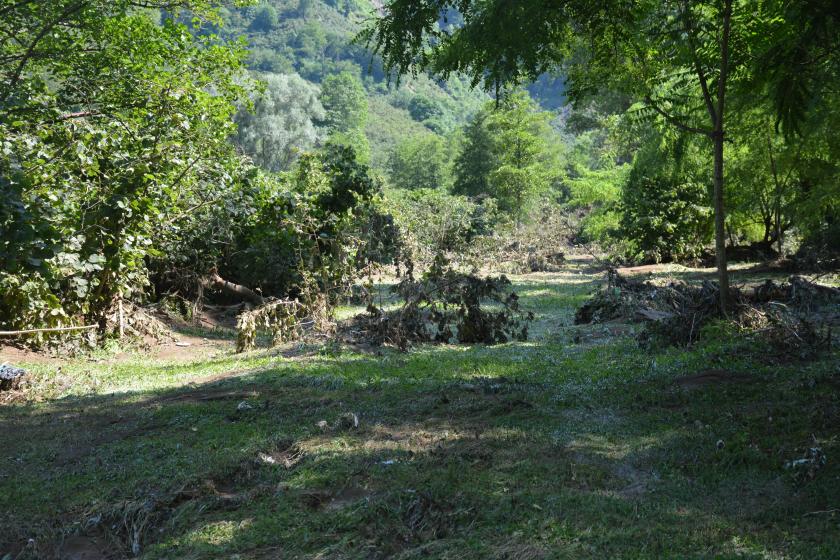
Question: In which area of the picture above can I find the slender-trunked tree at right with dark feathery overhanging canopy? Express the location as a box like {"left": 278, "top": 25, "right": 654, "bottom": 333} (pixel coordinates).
{"left": 362, "top": 0, "right": 808, "bottom": 313}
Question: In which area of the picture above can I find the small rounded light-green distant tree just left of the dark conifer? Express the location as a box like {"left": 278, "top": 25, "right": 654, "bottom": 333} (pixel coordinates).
{"left": 388, "top": 134, "right": 449, "bottom": 189}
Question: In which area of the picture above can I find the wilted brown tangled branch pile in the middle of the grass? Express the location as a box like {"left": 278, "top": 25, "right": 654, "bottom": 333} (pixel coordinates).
{"left": 356, "top": 257, "right": 533, "bottom": 349}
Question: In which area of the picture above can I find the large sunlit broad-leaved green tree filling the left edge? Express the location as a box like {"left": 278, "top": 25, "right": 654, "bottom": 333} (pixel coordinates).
{"left": 0, "top": 0, "right": 249, "bottom": 328}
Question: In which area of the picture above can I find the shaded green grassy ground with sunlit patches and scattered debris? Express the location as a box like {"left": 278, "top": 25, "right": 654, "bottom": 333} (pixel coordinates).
{"left": 0, "top": 263, "right": 840, "bottom": 560}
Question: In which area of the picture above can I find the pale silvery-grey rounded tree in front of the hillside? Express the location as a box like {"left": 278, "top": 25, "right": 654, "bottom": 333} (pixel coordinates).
{"left": 235, "top": 74, "right": 325, "bottom": 171}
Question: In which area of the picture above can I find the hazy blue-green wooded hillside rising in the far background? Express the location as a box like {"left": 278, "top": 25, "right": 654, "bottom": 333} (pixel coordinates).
{"left": 205, "top": 0, "right": 489, "bottom": 170}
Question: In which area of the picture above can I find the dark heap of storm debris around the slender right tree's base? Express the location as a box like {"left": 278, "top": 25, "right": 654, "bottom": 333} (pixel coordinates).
{"left": 575, "top": 269, "right": 840, "bottom": 358}
